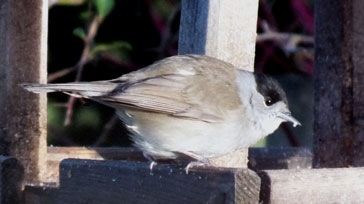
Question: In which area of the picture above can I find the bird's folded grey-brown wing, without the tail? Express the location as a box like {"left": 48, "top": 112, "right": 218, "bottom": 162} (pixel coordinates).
{"left": 97, "top": 69, "right": 240, "bottom": 122}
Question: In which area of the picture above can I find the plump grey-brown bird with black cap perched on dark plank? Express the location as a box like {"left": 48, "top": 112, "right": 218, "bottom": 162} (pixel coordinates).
{"left": 22, "top": 54, "right": 301, "bottom": 173}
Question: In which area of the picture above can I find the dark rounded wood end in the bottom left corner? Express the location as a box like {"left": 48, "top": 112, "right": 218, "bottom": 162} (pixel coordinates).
{"left": 0, "top": 156, "right": 23, "bottom": 204}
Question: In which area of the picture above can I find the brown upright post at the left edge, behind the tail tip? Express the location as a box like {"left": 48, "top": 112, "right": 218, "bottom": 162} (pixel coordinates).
{"left": 0, "top": 0, "right": 48, "bottom": 181}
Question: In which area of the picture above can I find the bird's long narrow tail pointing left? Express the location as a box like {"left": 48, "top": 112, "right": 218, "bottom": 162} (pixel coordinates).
{"left": 21, "top": 81, "right": 117, "bottom": 98}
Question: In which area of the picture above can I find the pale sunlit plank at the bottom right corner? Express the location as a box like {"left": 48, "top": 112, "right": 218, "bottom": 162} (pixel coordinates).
{"left": 260, "top": 168, "right": 364, "bottom": 204}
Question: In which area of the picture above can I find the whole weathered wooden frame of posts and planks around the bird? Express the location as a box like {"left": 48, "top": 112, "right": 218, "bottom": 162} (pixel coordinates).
{"left": 0, "top": 0, "right": 364, "bottom": 204}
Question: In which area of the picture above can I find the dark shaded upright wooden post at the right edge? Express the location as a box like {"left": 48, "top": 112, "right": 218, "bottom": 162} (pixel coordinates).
{"left": 314, "top": 0, "right": 364, "bottom": 167}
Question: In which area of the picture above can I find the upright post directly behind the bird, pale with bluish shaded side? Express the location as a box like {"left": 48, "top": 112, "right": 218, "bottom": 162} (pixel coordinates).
{"left": 178, "top": 0, "right": 258, "bottom": 167}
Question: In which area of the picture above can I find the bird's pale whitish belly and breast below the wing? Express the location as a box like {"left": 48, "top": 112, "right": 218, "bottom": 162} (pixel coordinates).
{"left": 119, "top": 107, "right": 272, "bottom": 159}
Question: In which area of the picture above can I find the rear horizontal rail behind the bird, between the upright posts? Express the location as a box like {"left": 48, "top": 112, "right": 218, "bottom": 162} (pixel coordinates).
{"left": 47, "top": 147, "right": 312, "bottom": 182}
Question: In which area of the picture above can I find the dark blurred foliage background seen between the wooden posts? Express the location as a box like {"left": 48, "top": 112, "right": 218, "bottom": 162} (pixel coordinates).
{"left": 48, "top": 0, "right": 314, "bottom": 148}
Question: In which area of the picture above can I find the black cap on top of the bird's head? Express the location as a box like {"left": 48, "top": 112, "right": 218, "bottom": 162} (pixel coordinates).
{"left": 254, "top": 73, "right": 288, "bottom": 106}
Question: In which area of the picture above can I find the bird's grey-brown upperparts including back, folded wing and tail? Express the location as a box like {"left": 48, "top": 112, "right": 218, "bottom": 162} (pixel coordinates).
{"left": 23, "top": 55, "right": 245, "bottom": 122}
